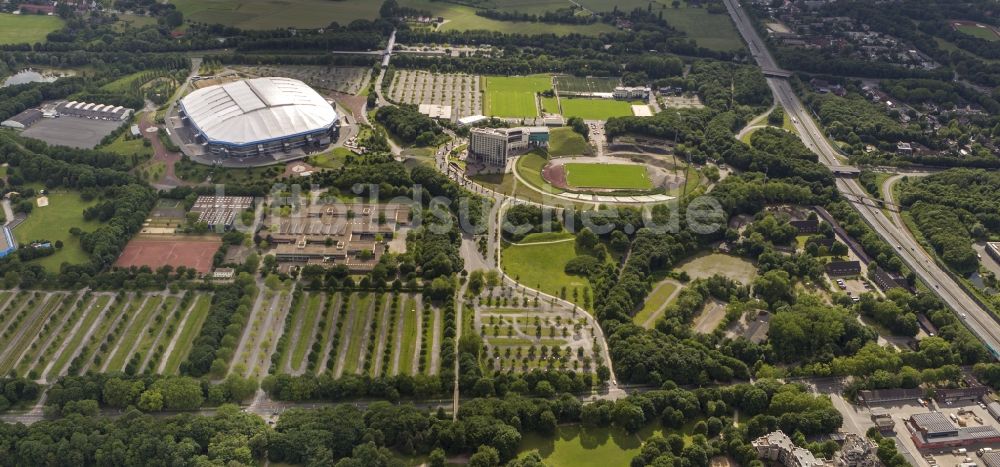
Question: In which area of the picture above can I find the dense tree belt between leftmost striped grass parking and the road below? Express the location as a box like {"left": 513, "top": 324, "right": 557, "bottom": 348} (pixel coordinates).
{"left": 45, "top": 373, "right": 257, "bottom": 415}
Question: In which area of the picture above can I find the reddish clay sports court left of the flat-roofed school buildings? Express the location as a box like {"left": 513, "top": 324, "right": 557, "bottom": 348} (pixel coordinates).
{"left": 115, "top": 238, "right": 222, "bottom": 274}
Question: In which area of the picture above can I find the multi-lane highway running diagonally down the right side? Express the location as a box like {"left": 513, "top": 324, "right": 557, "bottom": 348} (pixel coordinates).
{"left": 725, "top": 0, "right": 1000, "bottom": 357}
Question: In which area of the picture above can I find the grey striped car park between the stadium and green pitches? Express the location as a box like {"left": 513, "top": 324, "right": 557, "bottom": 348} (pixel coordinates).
{"left": 388, "top": 70, "right": 483, "bottom": 118}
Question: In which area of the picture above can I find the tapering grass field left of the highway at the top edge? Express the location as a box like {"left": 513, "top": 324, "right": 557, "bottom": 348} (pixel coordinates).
{"left": 580, "top": 0, "right": 744, "bottom": 51}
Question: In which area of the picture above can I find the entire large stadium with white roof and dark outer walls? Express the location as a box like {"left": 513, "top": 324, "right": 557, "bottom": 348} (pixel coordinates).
{"left": 179, "top": 78, "right": 339, "bottom": 157}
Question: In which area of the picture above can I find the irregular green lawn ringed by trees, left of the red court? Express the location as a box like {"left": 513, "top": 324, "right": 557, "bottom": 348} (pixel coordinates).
{"left": 14, "top": 191, "right": 100, "bottom": 272}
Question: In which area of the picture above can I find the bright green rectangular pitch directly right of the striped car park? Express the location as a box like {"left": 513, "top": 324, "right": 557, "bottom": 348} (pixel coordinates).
{"left": 483, "top": 75, "right": 552, "bottom": 118}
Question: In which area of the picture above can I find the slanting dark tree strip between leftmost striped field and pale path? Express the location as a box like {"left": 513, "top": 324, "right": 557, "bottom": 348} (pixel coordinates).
{"left": 181, "top": 274, "right": 256, "bottom": 377}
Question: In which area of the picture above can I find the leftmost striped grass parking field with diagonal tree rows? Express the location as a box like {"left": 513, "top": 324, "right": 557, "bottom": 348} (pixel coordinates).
{"left": 0, "top": 291, "right": 211, "bottom": 381}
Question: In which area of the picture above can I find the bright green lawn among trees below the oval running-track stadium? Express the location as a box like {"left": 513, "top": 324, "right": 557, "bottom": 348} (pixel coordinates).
{"left": 502, "top": 240, "right": 590, "bottom": 304}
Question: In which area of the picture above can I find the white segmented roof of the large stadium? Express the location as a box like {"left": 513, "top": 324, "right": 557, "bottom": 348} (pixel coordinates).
{"left": 181, "top": 78, "right": 337, "bottom": 145}
